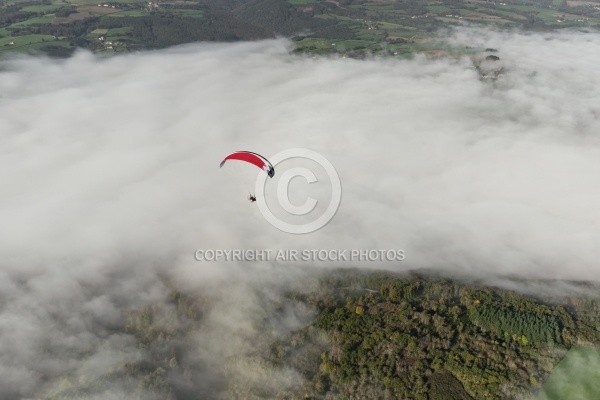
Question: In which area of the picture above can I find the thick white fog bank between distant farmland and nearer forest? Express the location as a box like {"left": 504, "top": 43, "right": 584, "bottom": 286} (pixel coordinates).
{"left": 0, "top": 29, "right": 600, "bottom": 397}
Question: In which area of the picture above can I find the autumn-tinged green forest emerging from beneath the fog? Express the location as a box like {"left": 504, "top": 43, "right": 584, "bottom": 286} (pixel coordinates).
{"left": 39, "top": 269, "right": 600, "bottom": 400}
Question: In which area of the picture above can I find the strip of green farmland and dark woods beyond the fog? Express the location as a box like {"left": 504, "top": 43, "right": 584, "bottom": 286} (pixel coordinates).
{"left": 0, "top": 0, "right": 600, "bottom": 58}
